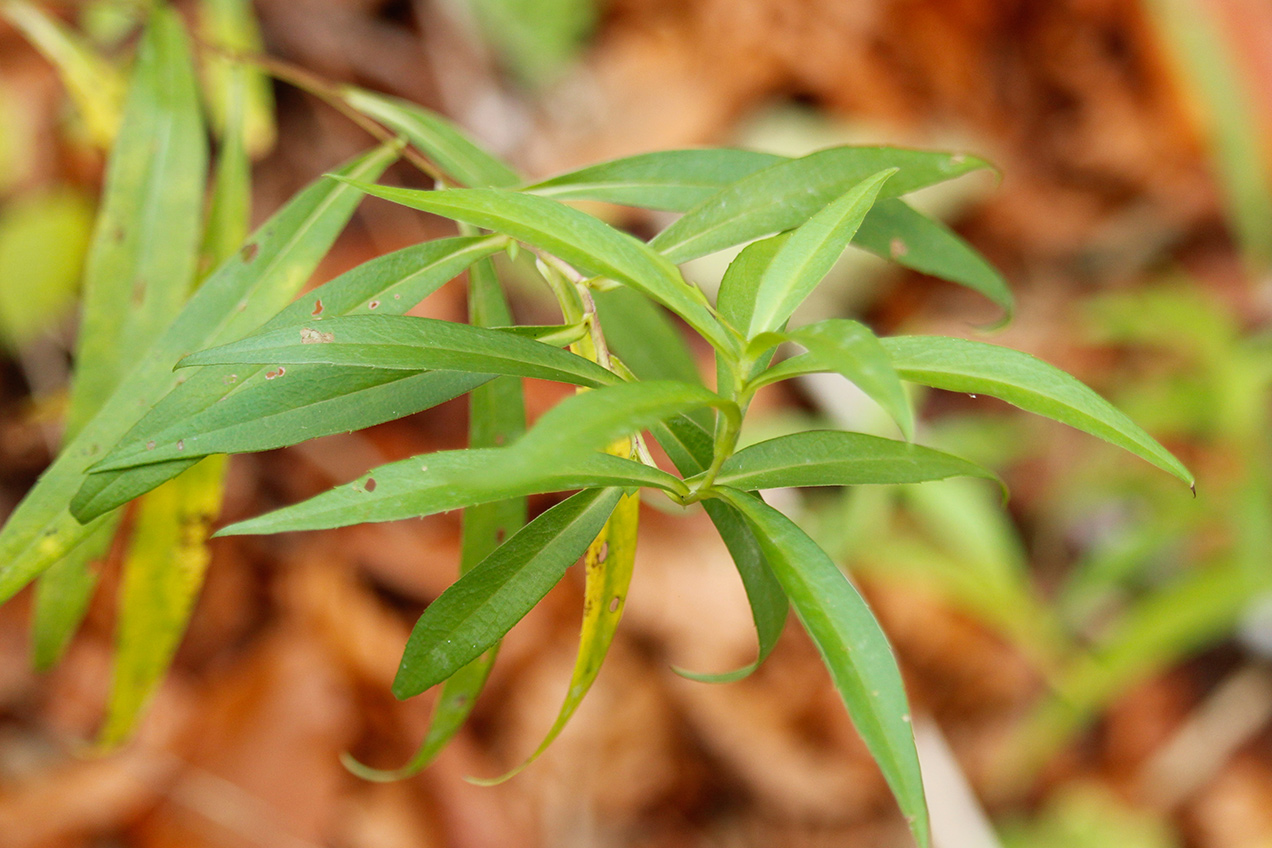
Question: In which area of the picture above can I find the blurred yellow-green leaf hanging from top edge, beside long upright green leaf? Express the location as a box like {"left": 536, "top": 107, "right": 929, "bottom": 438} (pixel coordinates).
{"left": 198, "top": 0, "right": 277, "bottom": 159}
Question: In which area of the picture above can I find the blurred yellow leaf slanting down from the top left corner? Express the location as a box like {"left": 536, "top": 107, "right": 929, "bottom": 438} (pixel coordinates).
{"left": 0, "top": 0, "right": 125, "bottom": 149}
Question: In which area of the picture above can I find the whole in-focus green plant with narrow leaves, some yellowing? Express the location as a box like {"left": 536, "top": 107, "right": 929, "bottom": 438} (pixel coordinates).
{"left": 0, "top": 4, "right": 1192, "bottom": 845}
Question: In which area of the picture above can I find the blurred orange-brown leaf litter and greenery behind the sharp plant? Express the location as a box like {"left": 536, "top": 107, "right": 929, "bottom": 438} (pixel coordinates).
{"left": 0, "top": 0, "right": 1272, "bottom": 848}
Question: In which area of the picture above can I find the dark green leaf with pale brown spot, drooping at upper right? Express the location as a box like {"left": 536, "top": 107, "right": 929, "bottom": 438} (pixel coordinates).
{"left": 852, "top": 198, "right": 1014, "bottom": 318}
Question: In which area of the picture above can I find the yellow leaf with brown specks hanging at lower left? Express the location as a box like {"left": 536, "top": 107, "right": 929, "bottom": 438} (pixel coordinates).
{"left": 99, "top": 456, "right": 225, "bottom": 746}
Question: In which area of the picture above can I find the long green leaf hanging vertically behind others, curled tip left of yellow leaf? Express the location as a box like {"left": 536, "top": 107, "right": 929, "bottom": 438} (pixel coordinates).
{"left": 341, "top": 259, "right": 525, "bottom": 781}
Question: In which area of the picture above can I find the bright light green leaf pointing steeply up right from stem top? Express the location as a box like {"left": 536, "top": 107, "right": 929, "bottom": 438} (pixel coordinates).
{"left": 747, "top": 168, "right": 897, "bottom": 338}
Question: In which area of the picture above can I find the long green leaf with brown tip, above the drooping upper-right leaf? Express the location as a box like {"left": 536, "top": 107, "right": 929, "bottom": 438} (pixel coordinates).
{"left": 650, "top": 147, "right": 988, "bottom": 263}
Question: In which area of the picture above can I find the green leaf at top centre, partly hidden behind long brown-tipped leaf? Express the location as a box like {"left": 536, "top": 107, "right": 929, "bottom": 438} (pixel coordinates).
{"left": 522, "top": 147, "right": 785, "bottom": 212}
